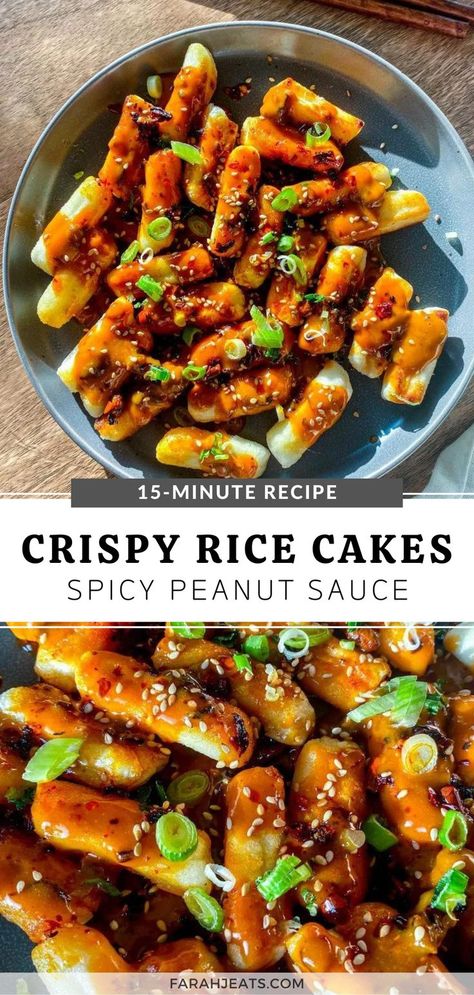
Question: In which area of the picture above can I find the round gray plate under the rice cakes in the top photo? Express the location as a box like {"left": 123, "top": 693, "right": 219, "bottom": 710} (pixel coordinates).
{"left": 5, "top": 21, "right": 474, "bottom": 477}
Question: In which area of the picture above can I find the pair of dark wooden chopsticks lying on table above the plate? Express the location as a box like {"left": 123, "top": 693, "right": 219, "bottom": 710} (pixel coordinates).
{"left": 310, "top": 0, "right": 474, "bottom": 38}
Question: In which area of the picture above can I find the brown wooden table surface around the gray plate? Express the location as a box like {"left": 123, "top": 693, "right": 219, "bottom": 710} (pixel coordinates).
{"left": 0, "top": 0, "right": 474, "bottom": 492}
